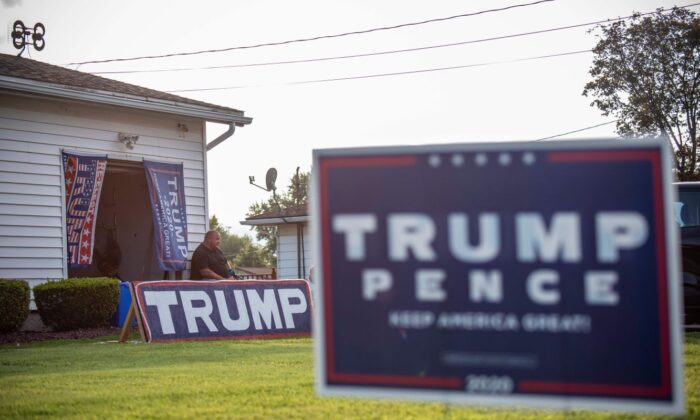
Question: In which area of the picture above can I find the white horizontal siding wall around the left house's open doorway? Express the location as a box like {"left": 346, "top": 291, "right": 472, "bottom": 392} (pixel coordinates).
{"left": 0, "top": 92, "right": 207, "bottom": 294}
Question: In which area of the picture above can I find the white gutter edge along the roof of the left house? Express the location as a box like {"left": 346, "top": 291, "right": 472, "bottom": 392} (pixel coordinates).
{"left": 0, "top": 76, "right": 253, "bottom": 127}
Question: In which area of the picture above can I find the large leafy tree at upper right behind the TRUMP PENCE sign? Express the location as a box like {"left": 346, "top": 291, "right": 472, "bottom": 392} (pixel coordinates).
{"left": 583, "top": 7, "right": 700, "bottom": 181}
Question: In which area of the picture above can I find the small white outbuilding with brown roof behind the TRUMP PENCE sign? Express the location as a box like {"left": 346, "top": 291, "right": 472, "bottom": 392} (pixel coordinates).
{"left": 241, "top": 205, "right": 313, "bottom": 279}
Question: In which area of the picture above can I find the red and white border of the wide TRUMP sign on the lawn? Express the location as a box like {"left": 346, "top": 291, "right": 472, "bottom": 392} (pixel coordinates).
{"left": 132, "top": 280, "right": 314, "bottom": 343}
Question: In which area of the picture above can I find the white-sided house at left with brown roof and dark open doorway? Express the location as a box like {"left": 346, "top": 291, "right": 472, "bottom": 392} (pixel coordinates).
{"left": 0, "top": 54, "right": 252, "bottom": 296}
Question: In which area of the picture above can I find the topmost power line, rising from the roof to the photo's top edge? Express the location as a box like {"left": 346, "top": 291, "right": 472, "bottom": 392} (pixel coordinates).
{"left": 67, "top": 0, "right": 555, "bottom": 66}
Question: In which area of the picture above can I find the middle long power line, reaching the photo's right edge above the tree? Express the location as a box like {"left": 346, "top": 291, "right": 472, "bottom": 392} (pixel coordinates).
{"left": 91, "top": 3, "right": 700, "bottom": 74}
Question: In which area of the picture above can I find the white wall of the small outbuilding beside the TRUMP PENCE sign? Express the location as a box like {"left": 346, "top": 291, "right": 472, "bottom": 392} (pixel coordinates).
{"left": 277, "top": 224, "right": 313, "bottom": 279}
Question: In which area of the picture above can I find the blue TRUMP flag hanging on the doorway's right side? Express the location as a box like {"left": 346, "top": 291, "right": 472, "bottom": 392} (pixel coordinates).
{"left": 143, "top": 160, "right": 188, "bottom": 271}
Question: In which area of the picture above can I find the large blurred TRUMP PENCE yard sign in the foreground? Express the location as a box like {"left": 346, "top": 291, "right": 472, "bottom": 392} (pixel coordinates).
{"left": 313, "top": 140, "right": 683, "bottom": 412}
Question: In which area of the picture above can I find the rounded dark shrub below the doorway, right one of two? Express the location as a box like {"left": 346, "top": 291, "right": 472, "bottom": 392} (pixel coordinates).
{"left": 34, "top": 277, "right": 119, "bottom": 331}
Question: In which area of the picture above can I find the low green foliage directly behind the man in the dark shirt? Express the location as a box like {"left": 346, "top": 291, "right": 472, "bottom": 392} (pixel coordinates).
{"left": 209, "top": 215, "right": 276, "bottom": 267}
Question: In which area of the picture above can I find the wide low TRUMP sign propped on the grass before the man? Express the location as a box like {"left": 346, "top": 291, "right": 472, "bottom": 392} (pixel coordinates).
{"left": 131, "top": 280, "right": 313, "bottom": 342}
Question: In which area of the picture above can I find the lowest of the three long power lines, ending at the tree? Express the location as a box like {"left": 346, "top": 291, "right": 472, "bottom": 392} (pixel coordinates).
{"left": 166, "top": 50, "right": 591, "bottom": 93}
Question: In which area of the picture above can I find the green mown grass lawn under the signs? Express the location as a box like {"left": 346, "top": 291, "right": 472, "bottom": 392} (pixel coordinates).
{"left": 0, "top": 333, "right": 700, "bottom": 420}
